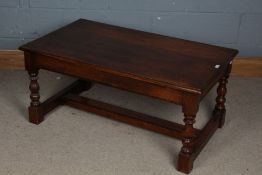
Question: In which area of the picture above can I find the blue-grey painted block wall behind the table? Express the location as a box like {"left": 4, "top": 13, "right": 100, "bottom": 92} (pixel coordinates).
{"left": 0, "top": 0, "right": 262, "bottom": 56}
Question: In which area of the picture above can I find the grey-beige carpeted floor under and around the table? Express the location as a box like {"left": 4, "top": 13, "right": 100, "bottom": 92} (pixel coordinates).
{"left": 0, "top": 71, "right": 262, "bottom": 175}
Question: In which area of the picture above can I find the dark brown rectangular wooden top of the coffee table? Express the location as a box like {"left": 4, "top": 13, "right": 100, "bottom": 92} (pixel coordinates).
{"left": 20, "top": 19, "right": 238, "bottom": 93}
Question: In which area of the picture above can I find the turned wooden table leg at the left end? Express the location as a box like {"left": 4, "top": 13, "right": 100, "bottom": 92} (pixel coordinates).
{"left": 28, "top": 70, "right": 43, "bottom": 124}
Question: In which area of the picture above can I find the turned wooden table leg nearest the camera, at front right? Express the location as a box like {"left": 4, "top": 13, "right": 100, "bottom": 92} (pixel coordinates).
{"left": 177, "top": 96, "right": 199, "bottom": 173}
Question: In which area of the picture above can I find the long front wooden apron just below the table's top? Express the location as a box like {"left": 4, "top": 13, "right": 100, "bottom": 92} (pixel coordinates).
{"left": 32, "top": 54, "right": 184, "bottom": 105}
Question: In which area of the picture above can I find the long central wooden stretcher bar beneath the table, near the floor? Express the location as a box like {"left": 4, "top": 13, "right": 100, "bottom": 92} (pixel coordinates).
{"left": 63, "top": 94, "right": 199, "bottom": 139}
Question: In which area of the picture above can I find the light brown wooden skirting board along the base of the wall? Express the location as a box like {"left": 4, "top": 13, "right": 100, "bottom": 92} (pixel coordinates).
{"left": 0, "top": 50, "right": 262, "bottom": 77}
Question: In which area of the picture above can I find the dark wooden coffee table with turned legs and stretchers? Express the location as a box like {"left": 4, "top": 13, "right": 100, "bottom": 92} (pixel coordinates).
{"left": 20, "top": 19, "right": 238, "bottom": 173}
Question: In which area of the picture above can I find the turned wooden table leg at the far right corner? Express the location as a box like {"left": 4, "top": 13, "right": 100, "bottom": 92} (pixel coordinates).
{"left": 214, "top": 64, "right": 232, "bottom": 128}
